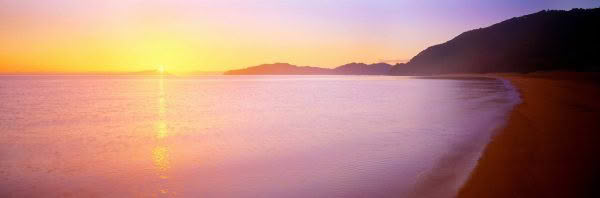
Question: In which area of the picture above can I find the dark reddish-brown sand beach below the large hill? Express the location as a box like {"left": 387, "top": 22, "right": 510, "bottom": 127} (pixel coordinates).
{"left": 458, "top": 72, "right": 600, "bottom": 197}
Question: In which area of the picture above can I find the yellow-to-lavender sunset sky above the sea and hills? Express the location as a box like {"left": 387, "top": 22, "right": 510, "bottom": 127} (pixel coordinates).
{"left": 0, "top": 0, "right": 600, "bottom": 73}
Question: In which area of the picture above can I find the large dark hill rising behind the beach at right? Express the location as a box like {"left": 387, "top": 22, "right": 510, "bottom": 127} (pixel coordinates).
{"left": 391, "top": 8, "right": 600, "bottom": 75}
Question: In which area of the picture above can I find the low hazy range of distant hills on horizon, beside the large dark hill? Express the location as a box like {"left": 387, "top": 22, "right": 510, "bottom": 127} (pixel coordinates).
{"left": 225, "top": 63, "right": 392, "bottom": 75}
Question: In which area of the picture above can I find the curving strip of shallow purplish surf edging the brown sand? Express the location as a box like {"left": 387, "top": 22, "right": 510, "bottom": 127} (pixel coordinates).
{"left": 407, "top": 74, "right": 522, "bottom": 197}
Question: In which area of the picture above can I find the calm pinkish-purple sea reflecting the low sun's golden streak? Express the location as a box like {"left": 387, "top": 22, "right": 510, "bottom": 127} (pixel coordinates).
{"left": 0, "top": 76, "right": 517, "bottom": 197}
